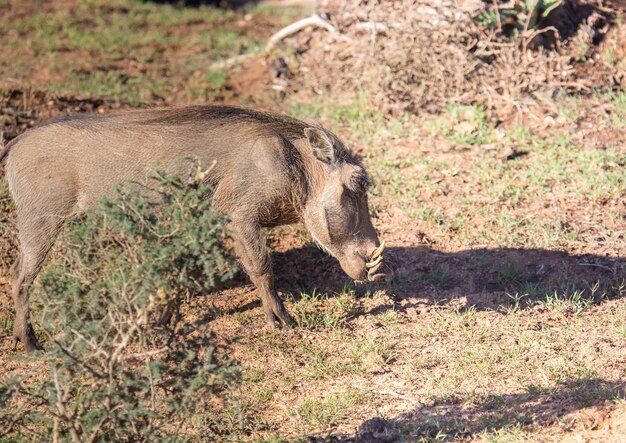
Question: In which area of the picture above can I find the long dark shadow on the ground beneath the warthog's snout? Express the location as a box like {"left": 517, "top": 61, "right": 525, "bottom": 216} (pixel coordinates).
{"left": 274, "top": 246, "right": 626, "bottom": 314}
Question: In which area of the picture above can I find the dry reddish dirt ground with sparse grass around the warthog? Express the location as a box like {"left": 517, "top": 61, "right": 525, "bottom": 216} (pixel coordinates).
{"left": 0, "top": 0, "right": 626, "bottom": 442}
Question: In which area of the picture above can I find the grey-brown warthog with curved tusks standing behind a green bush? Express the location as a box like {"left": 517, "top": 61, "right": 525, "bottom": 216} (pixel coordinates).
{"left": 0, "top": 106, "right": 386, "bottom": 352}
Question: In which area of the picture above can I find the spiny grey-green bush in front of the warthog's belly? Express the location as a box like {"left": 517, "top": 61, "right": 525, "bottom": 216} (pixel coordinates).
{"left": 0, "top": 168, "right": 238, "bottom": 442}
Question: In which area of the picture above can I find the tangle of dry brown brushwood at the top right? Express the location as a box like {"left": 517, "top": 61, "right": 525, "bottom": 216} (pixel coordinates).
{"left": 275, "top": 0, "right": 624, "bottom": 119}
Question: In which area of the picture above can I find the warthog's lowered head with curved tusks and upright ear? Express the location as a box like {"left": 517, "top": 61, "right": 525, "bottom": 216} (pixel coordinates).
{"left": 304, "top": 128, "right": 387, "bottom": 281}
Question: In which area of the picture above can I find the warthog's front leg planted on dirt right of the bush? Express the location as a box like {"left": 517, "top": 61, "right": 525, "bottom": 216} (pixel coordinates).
{"left": 231, "top": 222, "right": 295, "bottom": 328}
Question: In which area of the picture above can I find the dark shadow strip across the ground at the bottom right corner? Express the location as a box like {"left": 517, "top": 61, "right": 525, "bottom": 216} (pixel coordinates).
{"left": 326, "top": 378, "right": 626, "bottom": 443}
